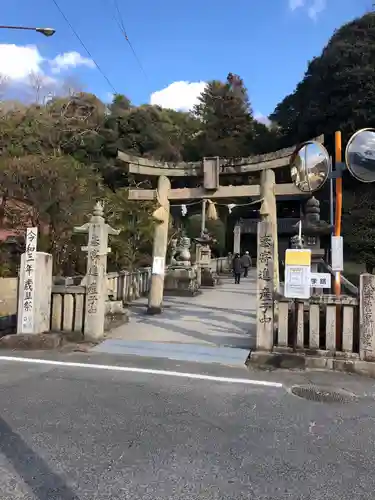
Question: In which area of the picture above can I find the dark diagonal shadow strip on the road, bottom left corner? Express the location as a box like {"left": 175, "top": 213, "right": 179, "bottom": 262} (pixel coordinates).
{"left": 0, "top": 417, "right": 80, "bottom": 500}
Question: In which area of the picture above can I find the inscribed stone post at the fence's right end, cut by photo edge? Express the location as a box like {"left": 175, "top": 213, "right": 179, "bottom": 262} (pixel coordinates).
{"left": 359, "top": 274, "right": 375, "bottom": 361}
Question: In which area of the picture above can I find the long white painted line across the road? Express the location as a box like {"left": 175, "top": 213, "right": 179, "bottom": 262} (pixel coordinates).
{"left": 0, "top": 356, "right": 283, "bottom": 388}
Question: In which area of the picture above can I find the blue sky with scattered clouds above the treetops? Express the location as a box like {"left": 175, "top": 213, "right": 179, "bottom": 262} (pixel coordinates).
{"left": 0, "top": 0, "right": 372, "bottom": 115}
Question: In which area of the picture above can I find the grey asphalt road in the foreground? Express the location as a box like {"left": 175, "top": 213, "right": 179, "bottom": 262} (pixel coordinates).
{"left": 0, "top": 354, "right": 375, "bottom": 500}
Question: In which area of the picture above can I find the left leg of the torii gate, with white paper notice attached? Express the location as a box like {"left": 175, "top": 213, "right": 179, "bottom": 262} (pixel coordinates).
{"left": 147, "top": 175, "right": 171, "bottom": 314}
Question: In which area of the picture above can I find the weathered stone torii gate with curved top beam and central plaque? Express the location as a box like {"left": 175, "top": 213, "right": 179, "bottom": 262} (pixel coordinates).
{"left": 117, "top": 136, "right": 324, "bottom": 314}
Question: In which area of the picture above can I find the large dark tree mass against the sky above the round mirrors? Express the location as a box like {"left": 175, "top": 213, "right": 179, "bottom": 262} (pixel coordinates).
{"left": 270, "top": 13, "right": 375, "bottom": 143}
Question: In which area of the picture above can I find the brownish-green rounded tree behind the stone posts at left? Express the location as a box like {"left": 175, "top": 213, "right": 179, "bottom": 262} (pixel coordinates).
{"left": 0, "top": 155, "right": 101, "bottom": 274}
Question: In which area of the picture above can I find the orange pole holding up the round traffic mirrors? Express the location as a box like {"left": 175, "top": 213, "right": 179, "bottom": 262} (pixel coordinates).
{"left": 335, "top": 131, "right": 342, "bottom": 349}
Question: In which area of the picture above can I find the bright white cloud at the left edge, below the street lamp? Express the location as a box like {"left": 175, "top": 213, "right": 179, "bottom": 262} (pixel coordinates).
{"left": 0, "top": 43, "right": 44, "bottom": 80}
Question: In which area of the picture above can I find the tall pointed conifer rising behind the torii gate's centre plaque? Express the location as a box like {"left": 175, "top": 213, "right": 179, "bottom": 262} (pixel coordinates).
{"left": 194, "top": 73, "right": 254, "bottom": 158}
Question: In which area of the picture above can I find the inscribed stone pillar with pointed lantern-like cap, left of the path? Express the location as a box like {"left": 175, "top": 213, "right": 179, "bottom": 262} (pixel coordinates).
{"left": 74, "top": 202, "right": 120, "bottom": 341}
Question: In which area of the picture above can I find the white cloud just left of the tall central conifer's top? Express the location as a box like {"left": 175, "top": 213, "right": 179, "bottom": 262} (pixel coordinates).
{"left": 150, "top": 81, "right": 206, "bottom": 111}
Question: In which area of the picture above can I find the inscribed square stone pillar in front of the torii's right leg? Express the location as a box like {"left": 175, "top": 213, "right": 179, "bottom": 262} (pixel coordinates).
{"left": 256, "top": 221, "right": 274, "bottom": 351}
